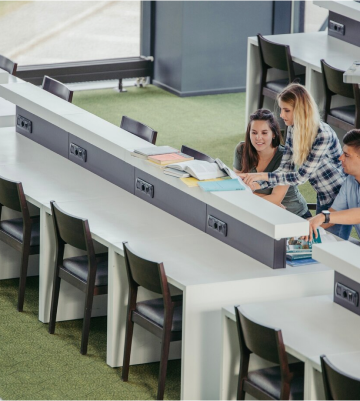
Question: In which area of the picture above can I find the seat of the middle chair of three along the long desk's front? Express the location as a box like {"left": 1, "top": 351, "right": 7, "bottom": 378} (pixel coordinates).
{"left": 62, "top": 253, "right": 108, "bottom": 286}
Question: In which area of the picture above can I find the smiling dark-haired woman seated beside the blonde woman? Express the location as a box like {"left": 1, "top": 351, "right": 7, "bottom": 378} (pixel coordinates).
{"left": 234, "top": 109, "right": 311, "bottom": 218}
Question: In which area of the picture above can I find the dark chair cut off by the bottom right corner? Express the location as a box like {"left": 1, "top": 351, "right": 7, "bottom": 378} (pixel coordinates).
{"left": 320, "top": 355, "right": 360, "bottom": 401}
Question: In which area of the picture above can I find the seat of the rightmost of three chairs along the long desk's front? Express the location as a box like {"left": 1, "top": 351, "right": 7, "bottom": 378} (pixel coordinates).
{"left": 136, "top": 295, "right": 182, "bottom": 331}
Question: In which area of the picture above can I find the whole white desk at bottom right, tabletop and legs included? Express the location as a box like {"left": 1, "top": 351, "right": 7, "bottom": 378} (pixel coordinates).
{"left": 221, "top": 295, "right": 360, "bottom": 401}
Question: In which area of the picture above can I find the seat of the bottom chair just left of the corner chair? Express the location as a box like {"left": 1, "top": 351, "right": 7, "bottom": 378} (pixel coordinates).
{"left": 247, "top": 362, "right": 304, "bottom": 401}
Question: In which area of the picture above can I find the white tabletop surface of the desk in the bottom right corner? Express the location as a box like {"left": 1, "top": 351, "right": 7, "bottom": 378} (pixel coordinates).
{"left": 224, "top": 295, "right": 360, "bottom": 360}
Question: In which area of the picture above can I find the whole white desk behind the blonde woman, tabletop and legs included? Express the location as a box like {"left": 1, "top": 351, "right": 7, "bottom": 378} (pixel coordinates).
{"left": 245, "top": 32, "right": 360, "bottom": 121}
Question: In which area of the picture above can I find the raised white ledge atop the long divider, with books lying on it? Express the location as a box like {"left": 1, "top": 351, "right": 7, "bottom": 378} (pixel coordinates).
{"left": 0, "top": 83, "right": 308, "bottom": 239}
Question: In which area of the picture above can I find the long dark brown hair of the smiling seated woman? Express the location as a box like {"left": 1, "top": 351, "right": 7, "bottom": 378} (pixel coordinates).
{"left": 238, "top": 109, "right": 281, "bottom": 173}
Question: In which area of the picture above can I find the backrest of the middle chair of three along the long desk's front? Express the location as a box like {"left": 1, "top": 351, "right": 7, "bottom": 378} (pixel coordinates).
{"left": 50, "top": 201, "right": 94, "bottom": 253}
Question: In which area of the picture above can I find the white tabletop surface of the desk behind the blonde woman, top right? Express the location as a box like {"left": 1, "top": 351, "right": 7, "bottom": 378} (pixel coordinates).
{"left": 249, "top": 31, "right": 360, "bottom": 72}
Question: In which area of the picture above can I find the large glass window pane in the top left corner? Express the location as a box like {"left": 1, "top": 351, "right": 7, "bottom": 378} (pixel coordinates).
{"left": 0, "top": 0, "right": 140, "bottom": 65}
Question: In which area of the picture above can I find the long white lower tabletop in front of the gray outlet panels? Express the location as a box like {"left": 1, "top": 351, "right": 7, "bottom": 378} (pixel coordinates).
{"left": 0, "top": 128, "right": 329, "bottom": 288}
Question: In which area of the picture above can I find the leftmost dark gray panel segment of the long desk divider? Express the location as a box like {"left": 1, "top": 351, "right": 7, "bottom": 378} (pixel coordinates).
{"left": 16, "top": 106, "right": 69, "bottom": 158}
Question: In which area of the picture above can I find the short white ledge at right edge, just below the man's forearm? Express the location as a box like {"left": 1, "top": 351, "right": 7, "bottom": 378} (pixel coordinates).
{"left": 313, "top": 241, "right": 360, "bottom": 283}
